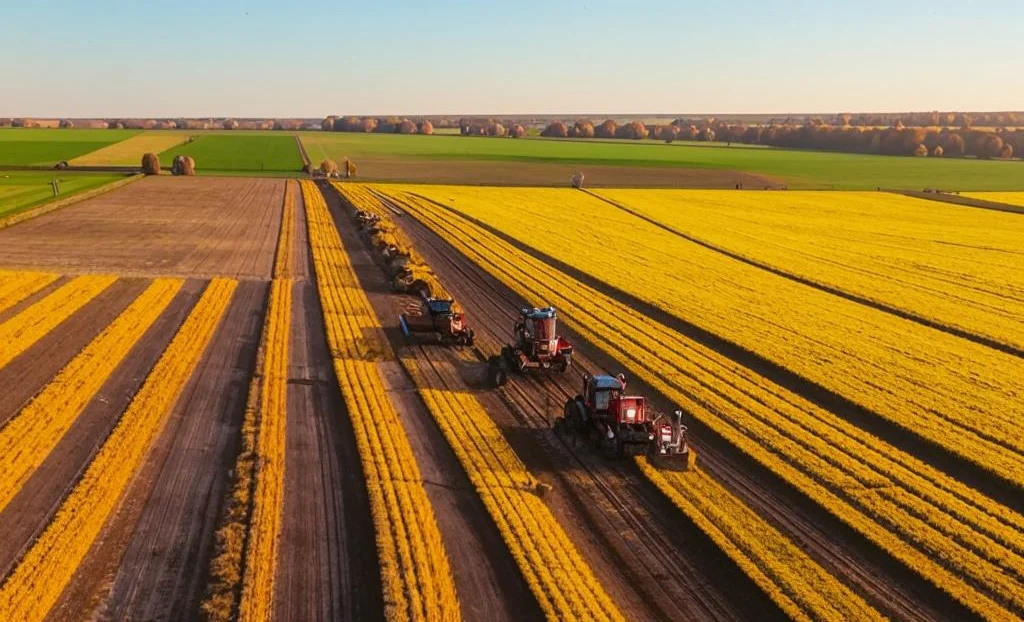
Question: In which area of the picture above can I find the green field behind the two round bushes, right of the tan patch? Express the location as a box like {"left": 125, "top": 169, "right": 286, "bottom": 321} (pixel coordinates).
{"left": 160, "top": 131, "right": 302, "bottom": 174}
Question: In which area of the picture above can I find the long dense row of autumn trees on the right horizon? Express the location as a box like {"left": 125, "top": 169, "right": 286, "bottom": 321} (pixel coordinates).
{"left": 541, "top": 118, "right": 1024, "bottom": 159}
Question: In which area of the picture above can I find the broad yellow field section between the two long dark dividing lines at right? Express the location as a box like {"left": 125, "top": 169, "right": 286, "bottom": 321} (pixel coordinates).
{"left": 395, "top": 186, "right": 1024, "bottom": 487}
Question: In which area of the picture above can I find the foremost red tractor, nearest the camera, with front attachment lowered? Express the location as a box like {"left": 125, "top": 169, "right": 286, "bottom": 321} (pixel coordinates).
{"left": 555, "top": 374, "right": 692, "bottom": 470}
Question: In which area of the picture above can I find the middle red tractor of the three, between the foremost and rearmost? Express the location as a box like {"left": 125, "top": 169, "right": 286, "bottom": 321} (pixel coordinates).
{"left": 489, "top": 306, "right": 572, "bottom": 386}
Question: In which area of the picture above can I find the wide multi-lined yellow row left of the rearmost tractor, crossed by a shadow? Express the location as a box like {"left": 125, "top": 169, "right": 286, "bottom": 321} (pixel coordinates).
{"left": 302, "top": 181, "right": 461, "bottom": 621}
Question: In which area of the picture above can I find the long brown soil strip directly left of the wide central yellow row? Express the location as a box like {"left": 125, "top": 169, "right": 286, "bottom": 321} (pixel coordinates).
{"left": 274, "top": 182, "right": 384, "bottom": 621}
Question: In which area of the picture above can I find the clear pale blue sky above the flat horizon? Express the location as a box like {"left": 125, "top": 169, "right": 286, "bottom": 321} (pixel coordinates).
{"left": 0, "top": 0, "right": 1024, "bottom": 117}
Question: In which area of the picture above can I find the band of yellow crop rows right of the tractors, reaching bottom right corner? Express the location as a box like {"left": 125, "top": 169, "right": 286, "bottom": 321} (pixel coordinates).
{"left": 392, "top": 193, "right": 1024, "bottom": 620}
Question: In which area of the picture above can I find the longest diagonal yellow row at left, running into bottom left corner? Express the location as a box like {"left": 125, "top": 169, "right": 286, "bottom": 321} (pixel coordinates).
{"left": 0, "top": 279, "right": 238, "bottom": 622}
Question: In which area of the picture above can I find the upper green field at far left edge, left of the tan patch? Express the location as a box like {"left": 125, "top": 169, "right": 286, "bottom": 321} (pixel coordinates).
{"left": 0, "top": 128, "right": 138, "bottom": 166}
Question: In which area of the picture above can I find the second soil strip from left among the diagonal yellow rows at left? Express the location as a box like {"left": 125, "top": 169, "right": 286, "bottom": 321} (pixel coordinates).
{"left": 0, "top": 279, "right": 148, "bottom": 426}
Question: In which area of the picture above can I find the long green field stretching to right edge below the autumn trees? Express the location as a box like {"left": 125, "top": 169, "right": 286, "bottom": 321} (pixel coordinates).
{"left": 301, "top": 131, "right": 1024, "bottom": 191}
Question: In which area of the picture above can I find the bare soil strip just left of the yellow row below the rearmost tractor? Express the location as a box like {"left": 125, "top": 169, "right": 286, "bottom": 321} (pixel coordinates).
{"left": 325, "top": 182, "right": 543, "bottom": 621}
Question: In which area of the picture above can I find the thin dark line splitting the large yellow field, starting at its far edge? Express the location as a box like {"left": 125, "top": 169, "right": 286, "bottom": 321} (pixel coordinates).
{"left": 580, "top": 189, "right": 1024, "bottom": 359}
